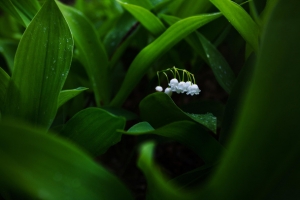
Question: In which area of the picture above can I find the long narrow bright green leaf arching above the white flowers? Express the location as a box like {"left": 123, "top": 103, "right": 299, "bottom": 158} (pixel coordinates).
{"left": 110, "top": 13, "right": 221, "bottom": 107}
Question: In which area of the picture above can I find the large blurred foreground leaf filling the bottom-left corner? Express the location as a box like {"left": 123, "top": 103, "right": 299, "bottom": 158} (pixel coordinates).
{"left": 0, "top": 121, "right": 133, "bottom": 200}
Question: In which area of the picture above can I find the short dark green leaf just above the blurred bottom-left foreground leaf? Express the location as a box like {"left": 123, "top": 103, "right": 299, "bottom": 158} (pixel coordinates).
{"left": 60, "top": 108, "right": 125, "bottom": 156}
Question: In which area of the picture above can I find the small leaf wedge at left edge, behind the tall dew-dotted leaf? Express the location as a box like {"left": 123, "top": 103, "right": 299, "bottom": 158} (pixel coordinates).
{"left": 0, "top": 40, "right": 18, "bottom": 72}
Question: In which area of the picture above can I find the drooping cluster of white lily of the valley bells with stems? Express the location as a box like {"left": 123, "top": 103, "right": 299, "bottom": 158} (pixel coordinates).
{"left": 155, "top": 67, "right": 201, "bottom": 96}
